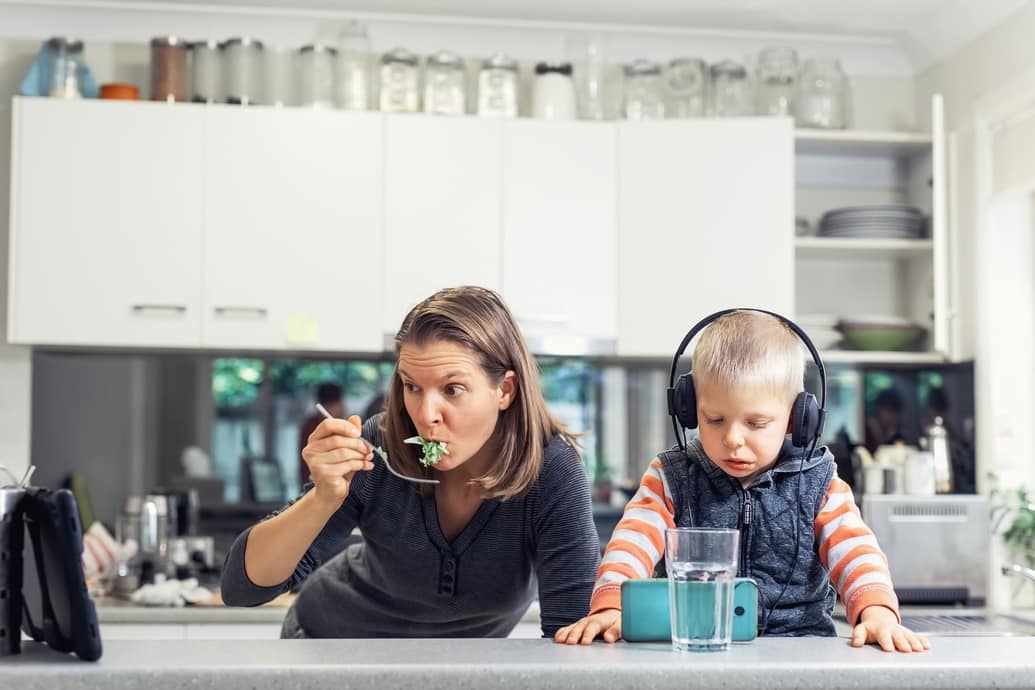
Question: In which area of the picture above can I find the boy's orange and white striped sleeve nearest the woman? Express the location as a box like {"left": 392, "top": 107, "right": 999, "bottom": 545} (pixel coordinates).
{"left": 589, "top": 457, "right": 675, "bottom": 613}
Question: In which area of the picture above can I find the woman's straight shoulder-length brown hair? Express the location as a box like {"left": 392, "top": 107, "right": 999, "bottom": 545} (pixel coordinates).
{"left": 382, "top": 286, "right": 578, "bottom": 499}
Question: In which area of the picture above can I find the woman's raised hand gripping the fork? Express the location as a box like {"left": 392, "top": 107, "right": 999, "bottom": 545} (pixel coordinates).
{"left": 302, "top": 415, "right": 374, "bottom": 510}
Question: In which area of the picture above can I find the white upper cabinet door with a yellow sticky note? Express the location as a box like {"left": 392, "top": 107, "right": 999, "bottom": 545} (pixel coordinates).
{"left": 202, "top": 107, "right": 382, "bottom": 351}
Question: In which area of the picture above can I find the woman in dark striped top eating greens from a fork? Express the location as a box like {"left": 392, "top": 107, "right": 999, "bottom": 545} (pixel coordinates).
{"left": 221, "top": 287, "right": 600, "bottom": 637}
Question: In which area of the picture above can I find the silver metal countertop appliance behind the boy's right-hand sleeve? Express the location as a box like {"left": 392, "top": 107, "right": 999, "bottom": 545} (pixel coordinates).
{"left": 862, "top": 494, "right": 992, "bottom": 606}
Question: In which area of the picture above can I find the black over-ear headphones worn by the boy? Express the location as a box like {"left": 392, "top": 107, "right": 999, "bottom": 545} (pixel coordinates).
{"left": 667, "top": 307, "right": 827, "bottom": 453}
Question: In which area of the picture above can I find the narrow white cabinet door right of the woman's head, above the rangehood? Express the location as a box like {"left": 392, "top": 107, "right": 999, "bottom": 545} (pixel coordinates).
{"left": 503, "top": 120, "right": 618, "bottom": 354}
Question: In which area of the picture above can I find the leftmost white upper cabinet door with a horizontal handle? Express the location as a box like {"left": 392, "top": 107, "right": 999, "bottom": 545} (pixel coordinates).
{"left": 8, "top": 98, "right": 204, "bottom": 347}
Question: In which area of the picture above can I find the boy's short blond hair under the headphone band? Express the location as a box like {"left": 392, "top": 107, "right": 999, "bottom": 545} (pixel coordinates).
{"left": 693, "top": 309, "right": 805, "bottom": 404}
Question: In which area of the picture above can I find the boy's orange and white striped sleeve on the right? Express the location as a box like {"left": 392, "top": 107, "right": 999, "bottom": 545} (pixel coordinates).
{"left": 816, "top": 475, "right": 901, "bottom": 625}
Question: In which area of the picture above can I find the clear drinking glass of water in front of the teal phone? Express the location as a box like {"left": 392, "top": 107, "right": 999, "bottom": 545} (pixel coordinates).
{"left": 664, "top": 528, "right": 740, "bottom": 652}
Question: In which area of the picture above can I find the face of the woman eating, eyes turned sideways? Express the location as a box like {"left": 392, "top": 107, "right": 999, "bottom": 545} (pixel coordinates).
{"left": 397, "top": 340, "right": 515, "bottom": 476}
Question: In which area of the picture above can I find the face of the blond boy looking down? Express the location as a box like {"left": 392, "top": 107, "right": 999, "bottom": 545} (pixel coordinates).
{"left": 697, "top": 386, "right": 791, "bottom": 486}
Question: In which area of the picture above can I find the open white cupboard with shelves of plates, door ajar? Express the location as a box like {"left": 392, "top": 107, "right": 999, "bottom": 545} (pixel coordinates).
{"left": 795, "top": 95, "right": 959, "bottom": 363}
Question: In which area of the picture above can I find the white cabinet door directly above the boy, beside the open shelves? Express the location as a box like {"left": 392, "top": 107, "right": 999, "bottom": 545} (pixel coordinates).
{"left": 618, "top": 118, "right": 794, "bottom": 357}
